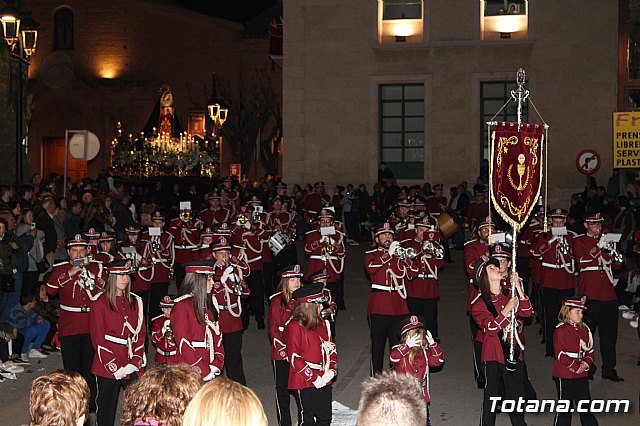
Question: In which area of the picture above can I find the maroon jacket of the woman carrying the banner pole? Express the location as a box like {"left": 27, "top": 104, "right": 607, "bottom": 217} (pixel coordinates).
{"left": 471, "top": 293, "right": 533, "bottom": 364}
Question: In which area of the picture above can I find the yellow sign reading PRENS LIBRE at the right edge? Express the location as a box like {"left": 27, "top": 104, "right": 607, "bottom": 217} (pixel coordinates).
{"left": 613, "top": 112, "right": 640, "bottom": 169}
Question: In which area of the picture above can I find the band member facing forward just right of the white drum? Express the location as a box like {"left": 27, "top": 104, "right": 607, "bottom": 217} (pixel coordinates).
{"left": 304, "top": 212, "right": 346, "bottom": 312}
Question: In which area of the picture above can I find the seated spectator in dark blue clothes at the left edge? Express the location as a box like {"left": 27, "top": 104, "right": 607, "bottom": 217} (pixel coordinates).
{"left": 7, "top": 294, "right": 50, "bottom": 359}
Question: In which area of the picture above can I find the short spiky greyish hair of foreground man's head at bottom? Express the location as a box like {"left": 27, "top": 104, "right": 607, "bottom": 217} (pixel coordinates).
{"left": 356, "top": 372, "right": 427, "bottom": 426}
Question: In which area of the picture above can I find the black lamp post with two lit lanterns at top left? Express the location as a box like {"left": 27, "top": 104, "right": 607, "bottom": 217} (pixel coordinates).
{"left": 0, "top": 5, "right": 39, "bottom": 185}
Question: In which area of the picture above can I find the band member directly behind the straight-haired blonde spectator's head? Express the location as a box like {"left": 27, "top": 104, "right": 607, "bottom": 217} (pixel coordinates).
{"left": 211, "top": 237, "right": 249, "bottom": 386}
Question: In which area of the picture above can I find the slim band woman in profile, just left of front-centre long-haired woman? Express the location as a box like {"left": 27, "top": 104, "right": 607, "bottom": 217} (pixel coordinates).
{"left": 269, "top": 265, "right": 302, "bottom": 426}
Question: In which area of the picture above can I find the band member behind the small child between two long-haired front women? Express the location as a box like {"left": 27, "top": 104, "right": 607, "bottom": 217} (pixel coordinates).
{"left": 140, "top": 211, "right": 175, "bottom": 324}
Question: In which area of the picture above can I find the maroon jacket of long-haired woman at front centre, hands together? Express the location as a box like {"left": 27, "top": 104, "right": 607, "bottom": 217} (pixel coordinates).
{"left": 284, "top": 319, "right": 338, "bottom": 390}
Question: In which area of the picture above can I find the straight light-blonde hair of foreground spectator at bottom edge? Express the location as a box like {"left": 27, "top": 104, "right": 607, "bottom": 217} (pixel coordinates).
{"left": 182, "top": 377, "right": 268, "bottom": 426}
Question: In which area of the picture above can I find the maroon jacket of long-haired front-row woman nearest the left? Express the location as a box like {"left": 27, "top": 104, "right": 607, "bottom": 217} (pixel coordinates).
{"left": 89, "top": 292, "right": 147, "bottom": 379}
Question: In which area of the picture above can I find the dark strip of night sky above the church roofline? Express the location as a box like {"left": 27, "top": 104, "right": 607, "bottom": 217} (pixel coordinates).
{"left": 171, "top": 0, "right": 277, "bottom": 23}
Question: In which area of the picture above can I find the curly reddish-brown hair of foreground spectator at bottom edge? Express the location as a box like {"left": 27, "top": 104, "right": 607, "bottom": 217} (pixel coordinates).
{"left": 121, "top": 364, "right": 202, "bottom": 426}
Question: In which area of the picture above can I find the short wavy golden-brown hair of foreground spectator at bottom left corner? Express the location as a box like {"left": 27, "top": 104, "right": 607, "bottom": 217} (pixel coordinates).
{"left": 29, "top": 370, "right": 89, "bottom": 426}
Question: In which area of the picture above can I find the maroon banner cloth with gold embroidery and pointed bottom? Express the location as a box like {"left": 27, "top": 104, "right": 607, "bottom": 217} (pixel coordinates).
{"left": 489, "top": 122, "right": 544, "bottom": 231}
